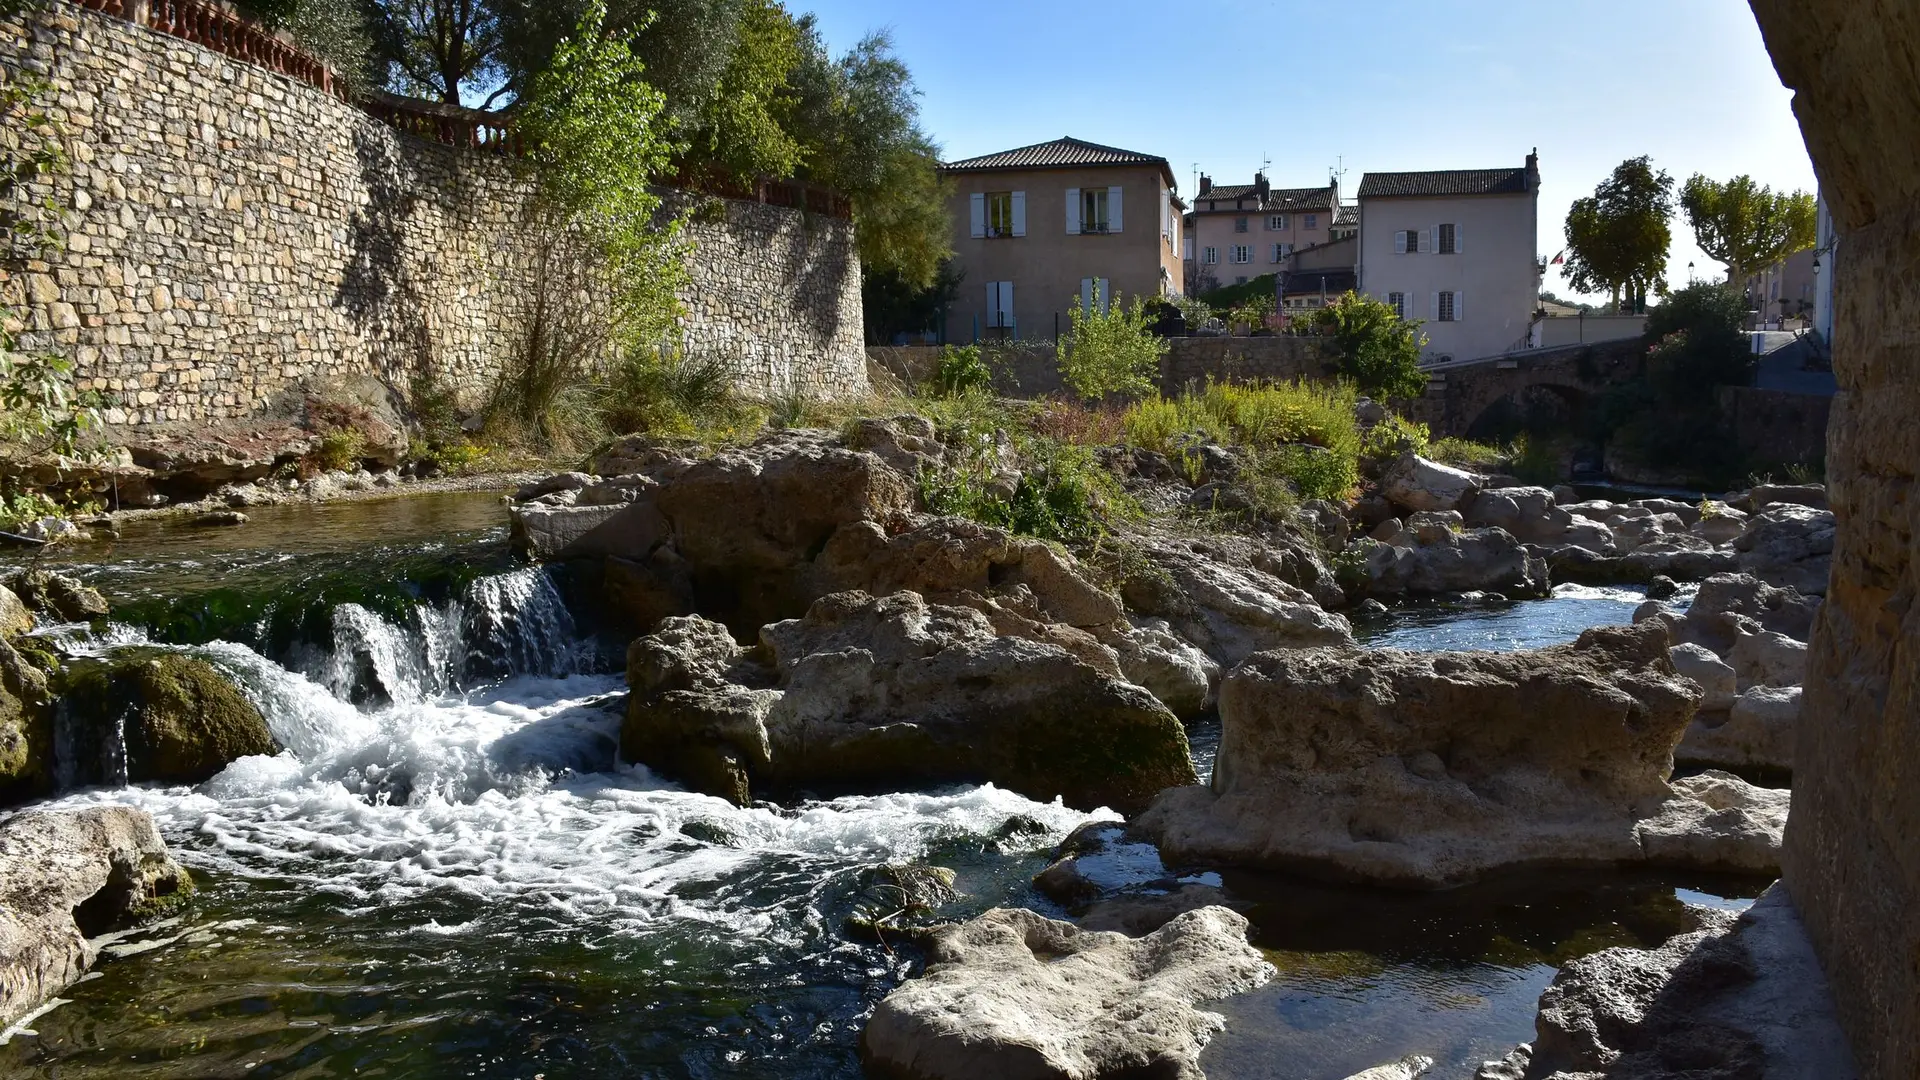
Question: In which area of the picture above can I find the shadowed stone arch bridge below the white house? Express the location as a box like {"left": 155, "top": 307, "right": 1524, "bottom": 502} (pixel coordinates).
{"left": 1411, "top": 338, "right": 1644, "bottom": 436}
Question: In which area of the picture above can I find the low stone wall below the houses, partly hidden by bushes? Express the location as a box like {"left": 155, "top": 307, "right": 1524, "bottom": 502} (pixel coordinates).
{"left": 866, "top": 336, "right": 1332, "bottom": 398}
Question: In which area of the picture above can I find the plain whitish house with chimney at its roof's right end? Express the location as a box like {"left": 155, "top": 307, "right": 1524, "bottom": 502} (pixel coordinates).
{"left": 1356, "top": 154, "right": 1544, "bottom": 363}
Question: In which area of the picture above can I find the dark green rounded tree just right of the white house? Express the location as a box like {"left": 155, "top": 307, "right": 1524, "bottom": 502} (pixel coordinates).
{"left": 1567, "top": 158, "right": 1674, "bottom": 309}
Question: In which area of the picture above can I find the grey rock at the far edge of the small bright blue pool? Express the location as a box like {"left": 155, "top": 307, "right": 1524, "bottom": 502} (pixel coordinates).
{"left": 1359, "top": 515, "right": 1549, "bottom": 596}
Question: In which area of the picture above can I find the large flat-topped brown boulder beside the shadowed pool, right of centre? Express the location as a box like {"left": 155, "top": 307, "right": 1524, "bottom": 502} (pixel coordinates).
{"left": 1135, "top": 626, "right": 1784, "bottom": 888}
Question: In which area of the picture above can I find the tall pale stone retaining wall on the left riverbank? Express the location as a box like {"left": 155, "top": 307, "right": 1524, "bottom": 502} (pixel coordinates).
{"left": 0, "top": 2, "right": 866, "bottom": 427}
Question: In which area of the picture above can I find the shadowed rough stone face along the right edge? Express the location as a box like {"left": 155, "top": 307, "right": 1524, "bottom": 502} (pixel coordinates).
{"left": 1751, "top": 0, "right": 1920, "bottom": 1078}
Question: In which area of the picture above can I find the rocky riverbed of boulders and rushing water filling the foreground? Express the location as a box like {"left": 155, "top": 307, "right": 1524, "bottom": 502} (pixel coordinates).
{"left": 0, "top": 405, "right": 1830, "bottom": 1080}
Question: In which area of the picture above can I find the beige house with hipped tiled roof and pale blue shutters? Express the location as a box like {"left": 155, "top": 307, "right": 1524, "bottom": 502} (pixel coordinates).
{"left": 941, "top": 138, "right": 1185, "bottom": 342}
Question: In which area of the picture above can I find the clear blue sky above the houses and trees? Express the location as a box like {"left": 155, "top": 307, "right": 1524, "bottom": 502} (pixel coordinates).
{"left": 802, "top": 0, "right": 1814, "bottom": 296}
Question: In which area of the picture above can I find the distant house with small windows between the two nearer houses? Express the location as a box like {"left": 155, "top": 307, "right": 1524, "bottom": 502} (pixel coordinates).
{"left": 1183, "top": 173, "right": 1340, "bottom": 288}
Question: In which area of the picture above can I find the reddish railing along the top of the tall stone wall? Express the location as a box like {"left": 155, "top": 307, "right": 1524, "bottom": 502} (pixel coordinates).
{"left": 46, "top": 0, "right": 848, "bottom": 216}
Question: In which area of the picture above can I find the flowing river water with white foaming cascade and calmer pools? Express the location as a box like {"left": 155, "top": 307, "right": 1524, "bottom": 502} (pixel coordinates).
{"left": 0, "top": 496, "right": 1751, "bottom": 1080}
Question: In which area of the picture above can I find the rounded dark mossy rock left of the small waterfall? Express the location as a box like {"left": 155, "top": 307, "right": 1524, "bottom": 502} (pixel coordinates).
{"left": 61, "top": 650, "right": 280, "bottom": 784}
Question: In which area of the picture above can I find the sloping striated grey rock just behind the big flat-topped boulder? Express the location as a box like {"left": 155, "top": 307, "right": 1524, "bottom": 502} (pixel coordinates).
{"left": 1121, "top": 536, "right": 1354, "bottom": 669}
